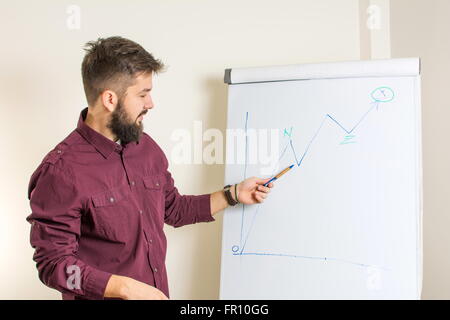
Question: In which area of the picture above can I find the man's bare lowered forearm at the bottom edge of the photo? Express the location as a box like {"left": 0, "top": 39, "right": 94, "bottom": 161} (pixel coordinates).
{"left": 104, "top": 275, "right": 169, "bottom": 300}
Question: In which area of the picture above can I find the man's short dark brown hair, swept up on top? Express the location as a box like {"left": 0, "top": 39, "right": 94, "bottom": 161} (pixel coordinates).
{"left": 81, "top": 37, "right": 164, "bottom": 106}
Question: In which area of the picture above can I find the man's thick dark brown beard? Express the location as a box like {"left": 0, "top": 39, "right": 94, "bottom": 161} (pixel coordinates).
{"left": 108, "top": 100, "right": 147, "bottom": 145}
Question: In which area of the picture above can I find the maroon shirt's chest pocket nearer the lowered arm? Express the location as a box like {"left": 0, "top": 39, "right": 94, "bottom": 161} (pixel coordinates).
{"left": 91, "top": 186, "right": 136, "bottom": 242}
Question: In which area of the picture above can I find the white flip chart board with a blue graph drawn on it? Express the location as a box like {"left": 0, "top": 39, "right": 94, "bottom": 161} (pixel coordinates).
{"left": 220, "top": 59, "right": 422, "bottom": 299}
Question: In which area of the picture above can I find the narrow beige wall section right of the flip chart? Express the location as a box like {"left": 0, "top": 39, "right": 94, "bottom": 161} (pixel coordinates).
{"left": 391, "top": 0, "right": 450, "bottom": 299}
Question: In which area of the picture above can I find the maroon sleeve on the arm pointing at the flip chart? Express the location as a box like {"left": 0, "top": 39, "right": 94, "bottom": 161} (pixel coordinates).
{"left": 164, "top": 170, "right": 215, "bottom": 228}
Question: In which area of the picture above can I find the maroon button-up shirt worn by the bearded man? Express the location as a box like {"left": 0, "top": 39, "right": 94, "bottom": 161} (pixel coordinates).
{"left": 27, "top": 108, "right": 214, "bottom": 299}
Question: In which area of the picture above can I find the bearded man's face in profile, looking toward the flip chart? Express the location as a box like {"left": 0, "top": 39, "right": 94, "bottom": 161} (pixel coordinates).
{"left": 108, "top": 74, "right": 153, "bottom": 144}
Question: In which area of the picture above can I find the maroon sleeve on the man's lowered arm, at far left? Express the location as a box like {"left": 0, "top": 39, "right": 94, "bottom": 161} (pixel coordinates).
{"left": 27, "top": 163, "right": 111, "bottom": 299}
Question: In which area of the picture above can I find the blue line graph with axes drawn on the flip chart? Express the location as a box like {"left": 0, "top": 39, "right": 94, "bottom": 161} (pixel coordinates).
{"left": 232, "top": 87, "right": 395, "bottom": 269}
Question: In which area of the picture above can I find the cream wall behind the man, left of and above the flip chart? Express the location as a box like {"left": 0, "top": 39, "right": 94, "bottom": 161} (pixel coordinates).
{"left": 0, "top": 0, "right": 360, "bottom": 299}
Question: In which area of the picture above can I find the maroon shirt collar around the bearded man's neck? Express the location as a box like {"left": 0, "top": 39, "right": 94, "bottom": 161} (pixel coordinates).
{"left": 76, "top": 108, "right": 139, "bottom": 159}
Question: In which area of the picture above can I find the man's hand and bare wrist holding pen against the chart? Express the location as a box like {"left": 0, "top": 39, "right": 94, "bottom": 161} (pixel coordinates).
{"left": 210, "top": 177, "right": 273, "bottom": 216}
